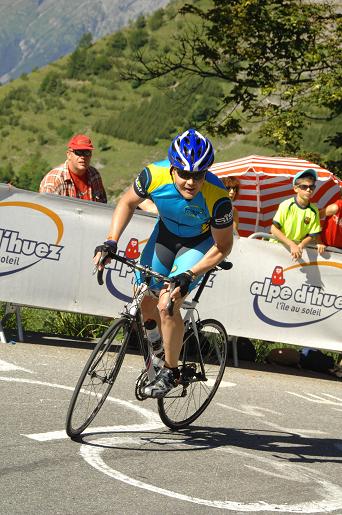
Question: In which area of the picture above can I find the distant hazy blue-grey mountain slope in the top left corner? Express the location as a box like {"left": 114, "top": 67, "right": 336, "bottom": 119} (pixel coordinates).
{"left": 0, "top": 0, "right": 168, "bottom": 82}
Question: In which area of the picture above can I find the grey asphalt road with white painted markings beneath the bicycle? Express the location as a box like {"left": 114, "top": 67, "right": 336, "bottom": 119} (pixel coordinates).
{"left": 0, "top": 341, "right": 342, "bottom": 515}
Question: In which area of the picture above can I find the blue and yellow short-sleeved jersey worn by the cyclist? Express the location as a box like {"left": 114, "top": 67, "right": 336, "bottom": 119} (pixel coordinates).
{"left": 134, "top": 161, "right": 233, "bottom": 238}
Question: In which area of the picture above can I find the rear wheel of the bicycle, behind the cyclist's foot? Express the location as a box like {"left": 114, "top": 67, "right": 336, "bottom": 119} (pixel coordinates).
{"left": 158, "top": 319, "right": 228, "bottom": 429}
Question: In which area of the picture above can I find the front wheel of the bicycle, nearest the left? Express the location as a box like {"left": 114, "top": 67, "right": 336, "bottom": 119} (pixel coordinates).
{"left": 66, "top": 318, "right": 132, "bottom": 438}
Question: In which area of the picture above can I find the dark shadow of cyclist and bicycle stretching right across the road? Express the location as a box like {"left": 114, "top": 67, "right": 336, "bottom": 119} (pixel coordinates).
{"left": 77, "top": 427, "right": 342, "bottom": 464}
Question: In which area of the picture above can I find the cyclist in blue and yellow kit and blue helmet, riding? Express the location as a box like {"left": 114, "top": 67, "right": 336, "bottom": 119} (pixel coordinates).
{"left": 94, "top": 129, "right": 233, "bottom": 398}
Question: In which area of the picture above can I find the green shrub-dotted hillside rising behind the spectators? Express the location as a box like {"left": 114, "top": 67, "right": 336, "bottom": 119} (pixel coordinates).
{"left": 0, "top": 0, "right": 340, "bottom": 202}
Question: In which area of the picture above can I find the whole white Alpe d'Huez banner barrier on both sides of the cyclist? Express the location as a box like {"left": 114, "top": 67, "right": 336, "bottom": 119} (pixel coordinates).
{"left": 0, "top": 185, "right": 342, "bottom": 351}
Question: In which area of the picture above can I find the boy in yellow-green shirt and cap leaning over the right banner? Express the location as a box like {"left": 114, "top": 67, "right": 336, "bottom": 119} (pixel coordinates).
{"left": 271, "top": 168, "right": 321, "bottom": 259}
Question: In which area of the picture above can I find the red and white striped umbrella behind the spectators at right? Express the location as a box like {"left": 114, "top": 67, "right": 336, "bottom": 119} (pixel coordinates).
{"left": 210, "top": 156, "right": 342, "bottom": 236}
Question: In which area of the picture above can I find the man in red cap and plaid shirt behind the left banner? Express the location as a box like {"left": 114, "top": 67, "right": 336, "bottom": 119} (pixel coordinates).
{"left": 39, "top": 134, "right": 107, "bottom": 203}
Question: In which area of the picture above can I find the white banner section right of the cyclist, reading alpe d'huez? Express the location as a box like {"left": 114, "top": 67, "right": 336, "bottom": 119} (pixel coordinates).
{"left": 201, "top": 238, "right": 342, "bottom": 351}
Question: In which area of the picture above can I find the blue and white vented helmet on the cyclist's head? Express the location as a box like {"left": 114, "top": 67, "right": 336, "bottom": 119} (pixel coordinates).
{"left": 168, "top": 129, "right": 214, "bottom": 172}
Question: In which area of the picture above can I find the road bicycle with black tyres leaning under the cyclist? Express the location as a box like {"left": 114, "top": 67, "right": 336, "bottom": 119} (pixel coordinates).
{"left": 66, "top": 255, "right": 232, "bottom": 438}
